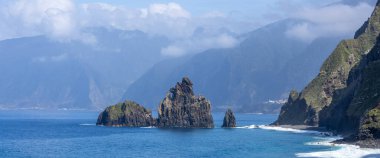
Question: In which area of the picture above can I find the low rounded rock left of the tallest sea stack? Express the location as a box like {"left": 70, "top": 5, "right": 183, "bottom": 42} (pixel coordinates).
{"left": 96, "top": 101, "right": 154, "bottom": 127}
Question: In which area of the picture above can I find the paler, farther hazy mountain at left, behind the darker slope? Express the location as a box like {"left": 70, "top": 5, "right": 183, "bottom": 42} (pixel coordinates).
{"left": 0, "top": 28, "right": 169, "bottom": 109}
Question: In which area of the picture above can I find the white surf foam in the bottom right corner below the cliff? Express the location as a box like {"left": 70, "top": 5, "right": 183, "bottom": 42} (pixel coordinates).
{"left": 296, "top": 137, "right": 380, "bottom": 158}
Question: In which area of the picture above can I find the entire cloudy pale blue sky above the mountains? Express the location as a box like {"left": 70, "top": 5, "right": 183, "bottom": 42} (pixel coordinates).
{"left": 0, "top": 0, "right": 374, "bottom": 56}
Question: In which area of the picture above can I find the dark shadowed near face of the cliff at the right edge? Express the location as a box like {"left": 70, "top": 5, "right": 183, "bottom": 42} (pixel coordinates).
{"left": 319, "top": 34, "right": 380, "bottom": 139}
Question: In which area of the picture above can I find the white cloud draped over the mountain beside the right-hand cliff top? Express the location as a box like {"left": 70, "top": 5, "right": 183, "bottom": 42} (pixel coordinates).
{"left": 286, "top": 3, "right": 373, "bottom": 41}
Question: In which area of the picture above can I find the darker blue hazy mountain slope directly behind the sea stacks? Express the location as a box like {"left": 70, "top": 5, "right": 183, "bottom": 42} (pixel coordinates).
{"left": 124, "top": 19, "right": 342, "bottom": 112}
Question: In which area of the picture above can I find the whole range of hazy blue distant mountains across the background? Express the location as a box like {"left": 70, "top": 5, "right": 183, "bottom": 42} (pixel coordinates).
{"left": 0, "top": 0, "right": 373, "bottom": 112}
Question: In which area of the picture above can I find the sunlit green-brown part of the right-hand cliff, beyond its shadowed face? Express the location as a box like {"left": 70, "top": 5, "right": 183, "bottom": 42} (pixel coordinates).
{"left": 274, "top": 2, "right": 380, "bottom": 128}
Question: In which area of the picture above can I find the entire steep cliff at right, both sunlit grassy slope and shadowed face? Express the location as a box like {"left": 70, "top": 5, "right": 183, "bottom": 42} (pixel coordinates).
{"left": 274, "top": 1, "right": 380, "bottom": 148}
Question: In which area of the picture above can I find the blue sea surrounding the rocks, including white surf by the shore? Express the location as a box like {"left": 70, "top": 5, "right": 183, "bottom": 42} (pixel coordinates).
{"left": 0, "top": 110, "right": 380, "bottom": 158}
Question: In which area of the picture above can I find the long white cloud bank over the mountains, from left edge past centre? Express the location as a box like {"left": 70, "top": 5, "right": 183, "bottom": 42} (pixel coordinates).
{"left": 0, "top": 0, "right": 245, "bottom": 56}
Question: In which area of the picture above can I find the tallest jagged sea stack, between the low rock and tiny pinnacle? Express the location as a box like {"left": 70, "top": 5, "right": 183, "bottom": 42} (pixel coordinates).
{"left": 157, "top": 77, "right": 214, "bottom": 128}
